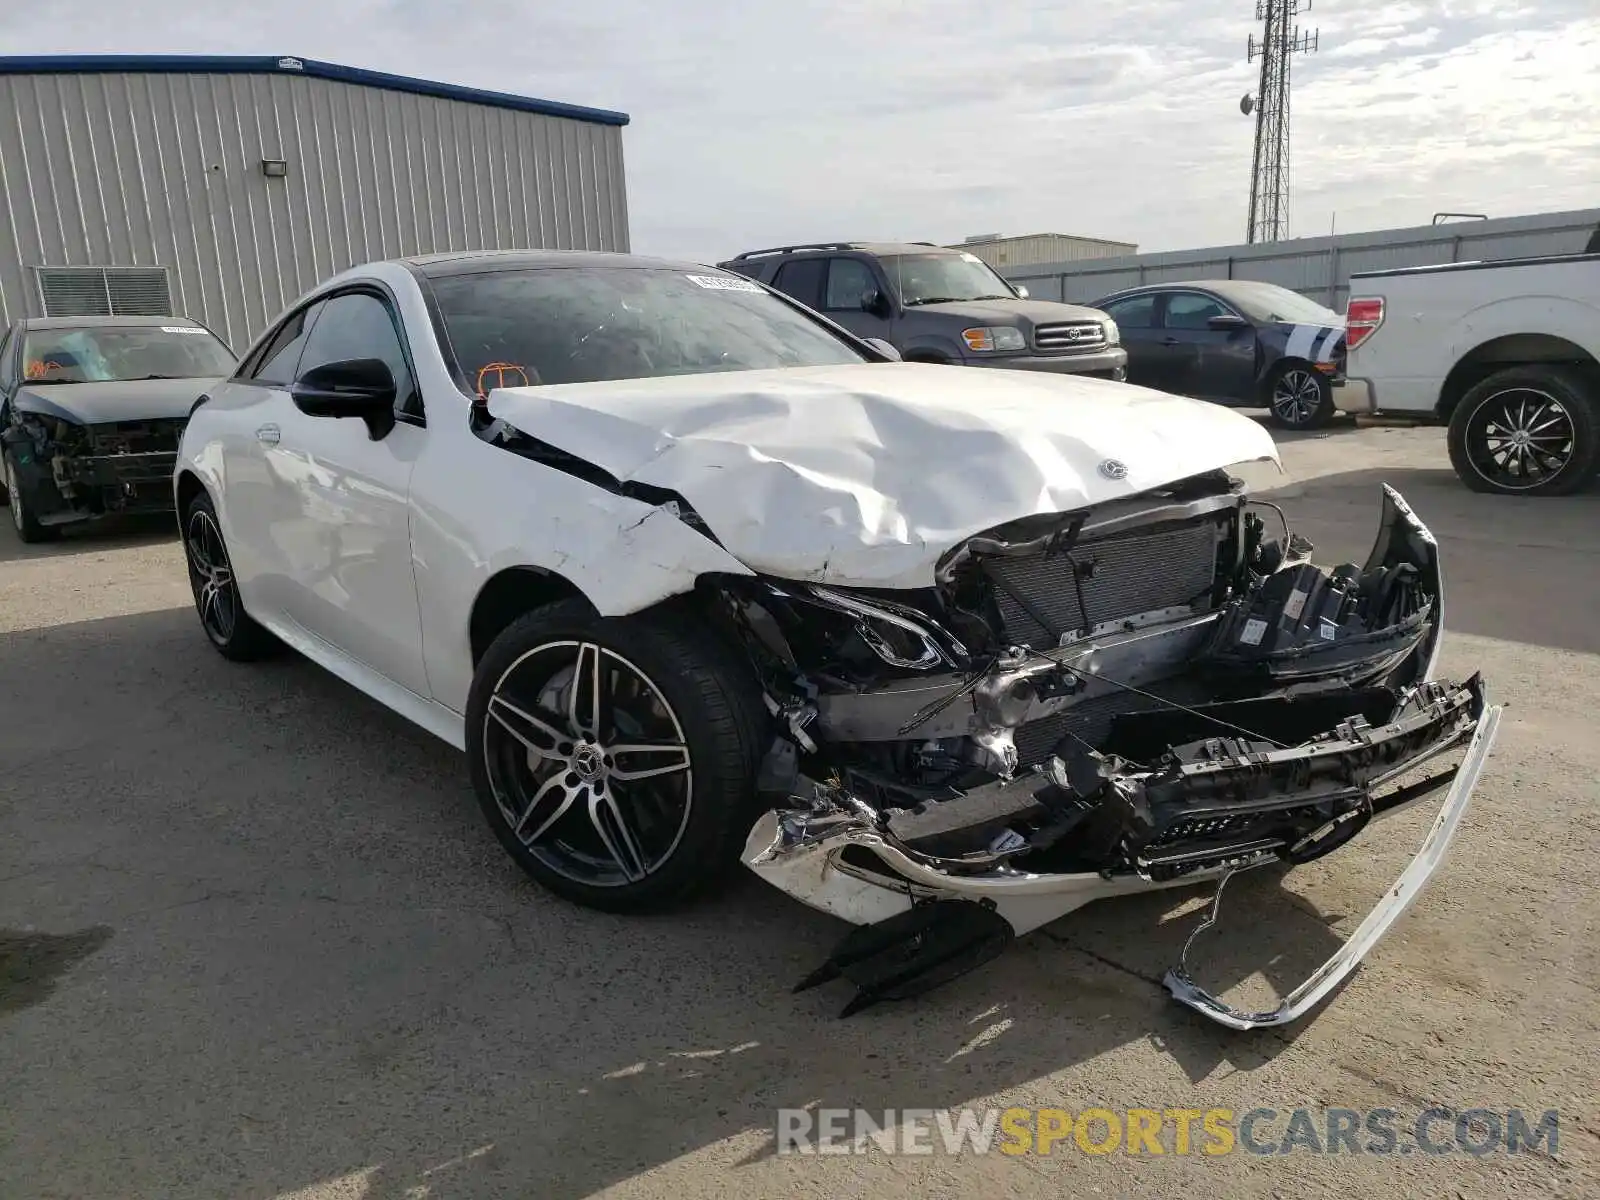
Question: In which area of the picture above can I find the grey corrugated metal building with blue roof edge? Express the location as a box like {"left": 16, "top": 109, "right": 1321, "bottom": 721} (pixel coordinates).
{"left": 0, "top": 56, "right": 629, "bottom": 352}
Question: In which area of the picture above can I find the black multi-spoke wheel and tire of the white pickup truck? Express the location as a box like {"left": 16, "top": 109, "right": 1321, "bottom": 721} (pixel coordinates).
{"left": 1450, "top": 366, "right": 1600, "bottom": 496}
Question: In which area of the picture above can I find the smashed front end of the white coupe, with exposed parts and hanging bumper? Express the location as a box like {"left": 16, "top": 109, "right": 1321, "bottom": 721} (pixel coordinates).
{"left": 720, "top": 483, "right": 1498, "bottom": 1027}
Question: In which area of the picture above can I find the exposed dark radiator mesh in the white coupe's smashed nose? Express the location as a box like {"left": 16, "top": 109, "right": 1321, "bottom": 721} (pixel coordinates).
{"left": 986, "top": 517, "right": 1224, "bottom": 650}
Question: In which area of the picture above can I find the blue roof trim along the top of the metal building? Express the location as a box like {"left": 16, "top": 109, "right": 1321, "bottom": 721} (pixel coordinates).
{"left": 0, "top": 54, "right": 629, "bottom": 125}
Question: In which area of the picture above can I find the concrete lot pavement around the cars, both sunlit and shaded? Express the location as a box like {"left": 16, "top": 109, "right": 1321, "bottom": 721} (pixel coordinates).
{"left": 0, "top": 426, "right": 1600, "bottom": 1200}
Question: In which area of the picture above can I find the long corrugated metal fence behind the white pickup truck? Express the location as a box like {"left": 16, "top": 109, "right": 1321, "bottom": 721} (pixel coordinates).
{"left": 998, "top": 208, "right": 1600, "bottom": 312}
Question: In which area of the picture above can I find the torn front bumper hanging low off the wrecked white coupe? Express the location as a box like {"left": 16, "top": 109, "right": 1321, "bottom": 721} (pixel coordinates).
{"left": 744, "top": 488, "right": 1501, "bottom": 1029}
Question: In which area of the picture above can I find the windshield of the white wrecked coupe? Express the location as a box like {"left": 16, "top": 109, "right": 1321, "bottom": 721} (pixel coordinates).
{"left": 432, "top": 267, "right": 867, "bottom": 394}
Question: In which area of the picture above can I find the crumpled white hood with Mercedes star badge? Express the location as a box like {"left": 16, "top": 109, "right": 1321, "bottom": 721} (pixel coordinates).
{"left": 488, "top": 363, "right": 1277, "bottom": 587}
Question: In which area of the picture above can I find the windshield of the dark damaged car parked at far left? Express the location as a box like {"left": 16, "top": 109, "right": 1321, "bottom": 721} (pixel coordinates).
{"left": 22, "top": 323, "right": 234, "bottom": 384}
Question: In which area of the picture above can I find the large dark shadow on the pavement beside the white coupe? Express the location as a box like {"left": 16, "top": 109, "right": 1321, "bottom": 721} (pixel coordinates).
{"left": 0, "top": 610, "right": 1362, "bottom": 1200}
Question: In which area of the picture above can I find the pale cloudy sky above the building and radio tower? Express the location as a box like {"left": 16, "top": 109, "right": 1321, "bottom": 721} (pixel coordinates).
{"left": 0, "top": 0, "right": 1600, "bottom": 259}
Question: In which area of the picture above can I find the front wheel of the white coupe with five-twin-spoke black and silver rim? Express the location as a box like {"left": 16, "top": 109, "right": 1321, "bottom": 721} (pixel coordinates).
{"left": 467, "top": 600, "right": 770, "bottom": 912}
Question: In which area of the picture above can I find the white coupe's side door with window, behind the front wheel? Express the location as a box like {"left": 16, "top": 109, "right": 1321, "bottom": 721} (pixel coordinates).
{"left": 259, "top": 285, "right": 427, "bottom": 696}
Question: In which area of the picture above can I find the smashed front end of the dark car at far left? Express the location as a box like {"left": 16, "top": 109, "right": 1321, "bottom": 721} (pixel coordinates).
{"left": 0, "top": 406, "right": 186, "bottom": 528}
